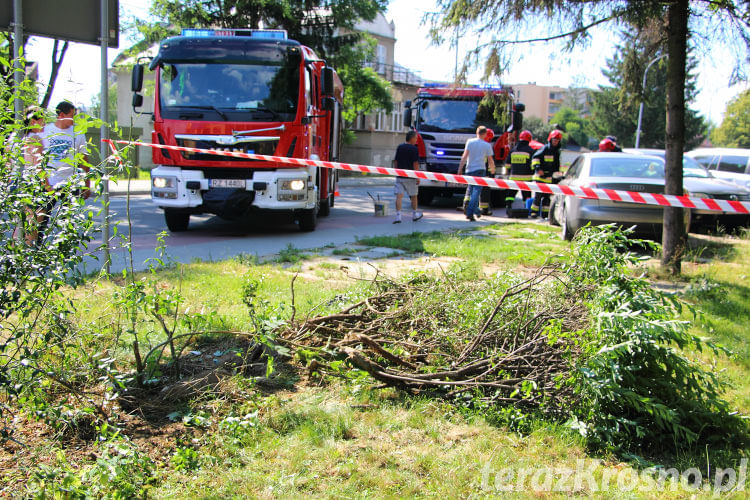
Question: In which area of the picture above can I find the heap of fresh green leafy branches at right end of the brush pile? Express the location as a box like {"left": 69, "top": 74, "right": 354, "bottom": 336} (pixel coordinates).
{"left": 567, "top": 227, "right": 747, "bottom": 451}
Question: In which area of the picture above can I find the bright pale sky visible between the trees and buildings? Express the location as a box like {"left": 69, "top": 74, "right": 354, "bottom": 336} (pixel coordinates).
{"left": 20, "top": 0, "right": 748, "bottom": 123}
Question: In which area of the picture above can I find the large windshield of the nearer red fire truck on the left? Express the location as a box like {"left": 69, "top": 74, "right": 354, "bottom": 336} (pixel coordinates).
{"left": 159, "top": 57, "right": 300, "bottom": 121}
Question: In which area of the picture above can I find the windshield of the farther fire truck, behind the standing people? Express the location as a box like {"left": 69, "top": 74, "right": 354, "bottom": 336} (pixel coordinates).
{"left": 417, "top": 99, "right": 502, "bottom": 133}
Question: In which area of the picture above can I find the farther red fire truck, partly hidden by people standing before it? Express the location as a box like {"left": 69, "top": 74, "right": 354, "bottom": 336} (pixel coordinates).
{"left": 404, "top": 85, "right": 525, "bottom": 206}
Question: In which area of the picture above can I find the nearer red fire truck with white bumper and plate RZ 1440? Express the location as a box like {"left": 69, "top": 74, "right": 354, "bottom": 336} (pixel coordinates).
{"left": 132, "top": 29, "right": 344, "bottom": 231}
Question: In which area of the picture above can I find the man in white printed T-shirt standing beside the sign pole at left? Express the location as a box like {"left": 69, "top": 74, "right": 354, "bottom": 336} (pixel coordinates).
{"left": 37, "top": 101, "right": 91, "bottom": 242}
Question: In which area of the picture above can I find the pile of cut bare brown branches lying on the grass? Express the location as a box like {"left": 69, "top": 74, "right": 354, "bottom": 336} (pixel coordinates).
{"left": 280, "top": 266, "right": 588, "bottom": 411}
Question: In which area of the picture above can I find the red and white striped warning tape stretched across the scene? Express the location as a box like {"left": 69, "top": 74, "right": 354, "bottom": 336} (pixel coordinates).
{"left": 107, "top": 140, "right": 750, "bottom": 214}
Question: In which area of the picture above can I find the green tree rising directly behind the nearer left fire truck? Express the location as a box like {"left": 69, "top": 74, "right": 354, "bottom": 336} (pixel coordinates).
{"left": 133, "top": 0, "right": 392, "bottom": 114}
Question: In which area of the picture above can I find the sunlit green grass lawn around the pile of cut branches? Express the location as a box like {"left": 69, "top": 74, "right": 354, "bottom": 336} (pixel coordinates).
{"left": 7, "top": 223, "right": 750, "bottom": 498}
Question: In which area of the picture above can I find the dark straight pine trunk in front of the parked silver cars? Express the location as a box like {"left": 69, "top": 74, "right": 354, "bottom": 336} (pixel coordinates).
{"left": 661, "top": 0, "right": 690, "bottom": 276}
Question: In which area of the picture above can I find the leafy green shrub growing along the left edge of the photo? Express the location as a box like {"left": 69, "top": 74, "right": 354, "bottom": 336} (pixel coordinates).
{"left": 0, "top": 69, "right": 96, "bottom": 437}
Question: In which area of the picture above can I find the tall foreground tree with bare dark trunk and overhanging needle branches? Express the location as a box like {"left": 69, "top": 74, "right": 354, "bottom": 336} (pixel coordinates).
{"left": 428, "top": 0, "right": 750, "bottom": 275}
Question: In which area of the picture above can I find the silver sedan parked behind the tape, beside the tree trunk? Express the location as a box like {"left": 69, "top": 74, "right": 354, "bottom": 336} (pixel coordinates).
{"left": 549, "top": 153, "right": 690, "bottom": 240}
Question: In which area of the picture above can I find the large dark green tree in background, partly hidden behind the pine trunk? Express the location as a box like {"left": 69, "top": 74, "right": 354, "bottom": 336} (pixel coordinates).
{"left": 591, "top": 27, "right": 707, "bottom": 150}
